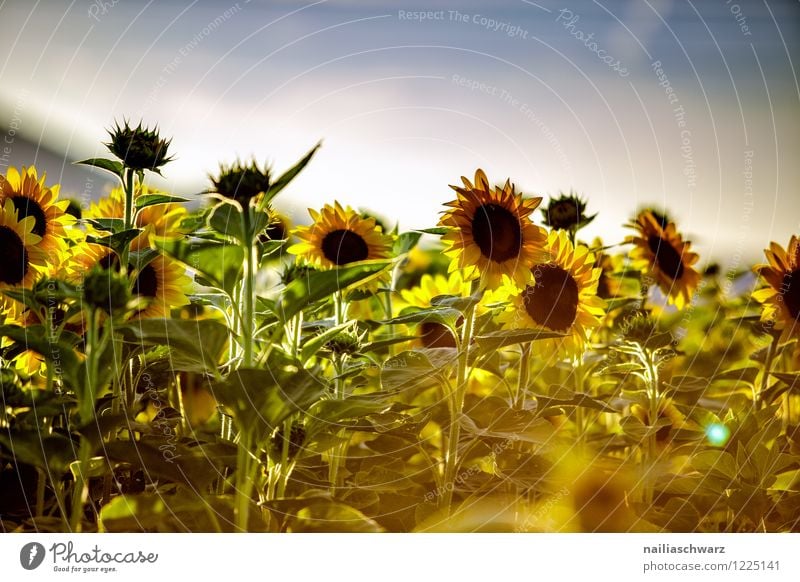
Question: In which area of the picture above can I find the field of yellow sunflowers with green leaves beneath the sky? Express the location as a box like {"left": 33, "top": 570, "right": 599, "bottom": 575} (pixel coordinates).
{"left": 0, "top": 122, "right": 800, "bottom": 532}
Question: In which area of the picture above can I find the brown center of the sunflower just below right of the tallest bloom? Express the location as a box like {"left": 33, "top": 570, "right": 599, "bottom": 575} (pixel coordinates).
{"left": 523, "top": 265, "right": 578, "bottom": 331}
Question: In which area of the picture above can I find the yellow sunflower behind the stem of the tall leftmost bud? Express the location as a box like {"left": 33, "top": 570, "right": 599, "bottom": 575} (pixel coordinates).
{"left": 84, "top": 185, "right": 187, "bottom": 251}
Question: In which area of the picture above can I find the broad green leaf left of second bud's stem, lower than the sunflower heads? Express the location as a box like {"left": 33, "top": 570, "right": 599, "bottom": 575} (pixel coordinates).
{"left": 120, "top": 319, "right": 228, "bottom": 374}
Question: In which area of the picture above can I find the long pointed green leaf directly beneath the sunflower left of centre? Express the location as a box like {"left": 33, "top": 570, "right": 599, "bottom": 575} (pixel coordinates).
{"left": 275, "top": 261, "right": 392, "bottom": 321}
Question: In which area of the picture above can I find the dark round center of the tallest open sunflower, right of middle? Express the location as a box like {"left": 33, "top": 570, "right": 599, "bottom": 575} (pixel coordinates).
{"left": 472, "top": 204, "right": 522, "bottom": 263}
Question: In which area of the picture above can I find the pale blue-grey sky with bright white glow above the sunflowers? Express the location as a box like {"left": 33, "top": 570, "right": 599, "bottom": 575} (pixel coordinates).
{"left": 0, "top": 0, "right": 800, "bottom": 267}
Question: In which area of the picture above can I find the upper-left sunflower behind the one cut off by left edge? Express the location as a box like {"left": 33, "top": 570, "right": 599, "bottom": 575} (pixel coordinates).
{"left": 0, "top": 166, "right": 75, "bottom": 263}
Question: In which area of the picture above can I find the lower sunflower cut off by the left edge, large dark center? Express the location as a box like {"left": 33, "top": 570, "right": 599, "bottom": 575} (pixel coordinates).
{"left": 0, "top": 198, "right": 47, "bottom": 291}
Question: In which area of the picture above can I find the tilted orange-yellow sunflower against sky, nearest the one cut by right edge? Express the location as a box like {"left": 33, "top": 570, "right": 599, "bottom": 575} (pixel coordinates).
{"left": 625, "top": 210, "right": 701, "bottom": 309}
